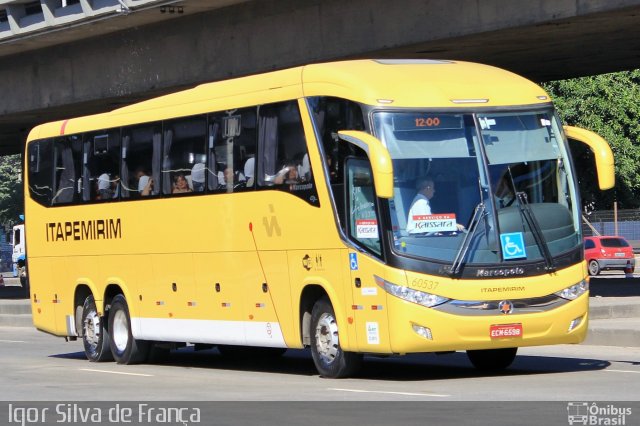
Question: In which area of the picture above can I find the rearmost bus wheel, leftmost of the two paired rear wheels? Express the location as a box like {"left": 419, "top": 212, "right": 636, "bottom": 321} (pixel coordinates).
{"left": 82, "top": 296, "right": 113, "bottom": 362}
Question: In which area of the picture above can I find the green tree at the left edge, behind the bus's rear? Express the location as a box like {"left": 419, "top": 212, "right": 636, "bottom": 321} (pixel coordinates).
{"left": 0, "top": 155, "right": 24, "bottom": 225}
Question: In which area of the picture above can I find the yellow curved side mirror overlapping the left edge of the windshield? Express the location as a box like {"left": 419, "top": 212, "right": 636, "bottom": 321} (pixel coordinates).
{"left": 338, "top": 130, "right": 393, "bottom": 198}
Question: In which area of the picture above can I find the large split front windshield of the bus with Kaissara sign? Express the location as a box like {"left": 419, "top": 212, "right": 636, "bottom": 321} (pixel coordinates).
{"left": 374, "top": 109, "right": 580, "bottom": 268}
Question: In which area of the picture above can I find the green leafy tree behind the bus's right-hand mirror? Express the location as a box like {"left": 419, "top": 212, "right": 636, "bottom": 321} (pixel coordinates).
{"left": 543, "top": 70, "right": 640, "bottom": 209}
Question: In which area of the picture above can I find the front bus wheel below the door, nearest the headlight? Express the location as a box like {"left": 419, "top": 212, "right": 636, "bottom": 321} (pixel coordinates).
{"left": 310, "top": 297, "right": 362, "bottom": 379}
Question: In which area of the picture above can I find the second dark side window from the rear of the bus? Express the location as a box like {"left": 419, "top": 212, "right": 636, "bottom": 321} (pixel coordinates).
{"left": 52, "top": 135, "right": 82, "bottom": 204}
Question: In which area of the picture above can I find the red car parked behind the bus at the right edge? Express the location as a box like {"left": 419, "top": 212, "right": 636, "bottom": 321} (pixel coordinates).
{"left": 584, "top": 236, "right": 636, "bottom": 275}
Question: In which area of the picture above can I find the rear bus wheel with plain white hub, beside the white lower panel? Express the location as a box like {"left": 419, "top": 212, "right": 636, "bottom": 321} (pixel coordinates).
{"left": 109, "top": 294, "right": 150, "bottom": 364}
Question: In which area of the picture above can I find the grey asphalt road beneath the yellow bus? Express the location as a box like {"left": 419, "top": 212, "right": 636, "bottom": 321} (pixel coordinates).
{"left": 0, "top": 327, "right": 640, "bottom": 401}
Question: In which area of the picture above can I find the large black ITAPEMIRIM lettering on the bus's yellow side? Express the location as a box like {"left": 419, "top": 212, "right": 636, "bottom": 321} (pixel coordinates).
{"left": 45, "top": 219, "right": 122, "bottom": 242}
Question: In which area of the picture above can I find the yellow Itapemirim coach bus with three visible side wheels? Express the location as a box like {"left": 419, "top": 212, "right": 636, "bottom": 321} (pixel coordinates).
{"left": 25, "top": 60, "right": 614, "bottom": 377}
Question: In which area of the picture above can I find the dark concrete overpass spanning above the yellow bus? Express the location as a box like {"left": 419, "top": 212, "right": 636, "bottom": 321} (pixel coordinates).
{"left": 0, "top": 0, "right": 640, "bottom": 154}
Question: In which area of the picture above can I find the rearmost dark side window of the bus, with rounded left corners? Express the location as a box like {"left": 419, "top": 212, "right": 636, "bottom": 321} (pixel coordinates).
{"left": 27, "top": 139, "right": 53, "bottom": 206}
